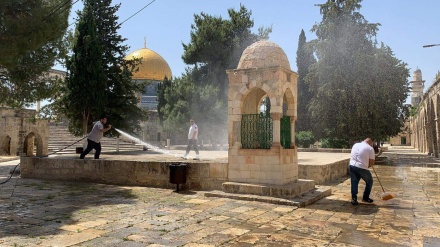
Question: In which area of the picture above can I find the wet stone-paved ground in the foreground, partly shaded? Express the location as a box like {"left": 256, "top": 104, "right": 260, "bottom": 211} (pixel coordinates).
{"left": 0, "top": 147, "right": 440, "bottom": 247}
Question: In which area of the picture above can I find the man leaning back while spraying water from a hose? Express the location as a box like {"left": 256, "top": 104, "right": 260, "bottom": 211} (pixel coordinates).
{"left": 79, "top": 115, "right": 112, "bottom": 159}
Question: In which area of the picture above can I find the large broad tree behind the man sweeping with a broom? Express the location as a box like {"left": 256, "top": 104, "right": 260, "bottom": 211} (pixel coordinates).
{"left": 306, "top": 0, "right": 409, "bottom": 144}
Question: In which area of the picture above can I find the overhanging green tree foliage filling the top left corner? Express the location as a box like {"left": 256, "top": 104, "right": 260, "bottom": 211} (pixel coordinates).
{"left": 0, "top": 0, "right": 71, "bottom": 107}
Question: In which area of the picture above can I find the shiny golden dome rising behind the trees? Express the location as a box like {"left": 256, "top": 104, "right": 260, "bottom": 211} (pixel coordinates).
{"left": 125, "top": 48, "right": 172, "bottom": 81}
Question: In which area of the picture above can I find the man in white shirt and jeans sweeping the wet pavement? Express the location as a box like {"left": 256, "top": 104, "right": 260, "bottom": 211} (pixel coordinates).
{"left": 349, "top": 138, "right": 375, "bottom": 205}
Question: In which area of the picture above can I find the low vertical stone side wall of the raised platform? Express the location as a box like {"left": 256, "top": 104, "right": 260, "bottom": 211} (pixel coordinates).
{"left": 20, "top": 157, "right": 348, "bottom": 190}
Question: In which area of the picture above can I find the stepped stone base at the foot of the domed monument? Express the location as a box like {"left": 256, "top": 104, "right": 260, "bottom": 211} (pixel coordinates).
{"left": 205, "top": 179, "right": 331, "bottom": 207}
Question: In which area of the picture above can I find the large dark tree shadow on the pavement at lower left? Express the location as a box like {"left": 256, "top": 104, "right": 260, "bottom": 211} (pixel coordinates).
{"left": 0, "top": 178, "right": 139, "bottom": 239}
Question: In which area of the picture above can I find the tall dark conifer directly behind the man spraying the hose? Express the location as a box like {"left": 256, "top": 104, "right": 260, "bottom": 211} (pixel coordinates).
{"left": 58, "top": 0, "right": 145, "bottom": 135}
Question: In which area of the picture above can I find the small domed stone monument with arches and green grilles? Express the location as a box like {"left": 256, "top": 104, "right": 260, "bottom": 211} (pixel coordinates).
{"left": 223, "top": 40, "right": 322, "bottom": 198}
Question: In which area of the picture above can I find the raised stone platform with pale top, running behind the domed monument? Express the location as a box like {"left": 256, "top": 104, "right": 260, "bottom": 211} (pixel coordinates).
{"left": 15, "top": 150, "right": 349, "bottom": 206}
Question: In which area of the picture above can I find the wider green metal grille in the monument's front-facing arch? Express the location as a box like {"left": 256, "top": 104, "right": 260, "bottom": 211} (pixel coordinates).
{"left": 241, "top": 114, "right": 273, "bottom": 149}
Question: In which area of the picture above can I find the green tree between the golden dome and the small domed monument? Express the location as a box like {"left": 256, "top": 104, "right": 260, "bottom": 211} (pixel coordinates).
{"left": 159, "top": 6, "right": 271, "bottom": 142}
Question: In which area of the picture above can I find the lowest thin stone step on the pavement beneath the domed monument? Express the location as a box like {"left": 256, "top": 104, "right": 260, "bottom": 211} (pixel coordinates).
{"left": 204, "top": 186, "right": 332, "bottom": 207}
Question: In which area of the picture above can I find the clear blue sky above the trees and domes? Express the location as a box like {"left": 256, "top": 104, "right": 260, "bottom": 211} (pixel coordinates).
{"left": 65, "top": 0, "right": 440, "bottom": 94}
